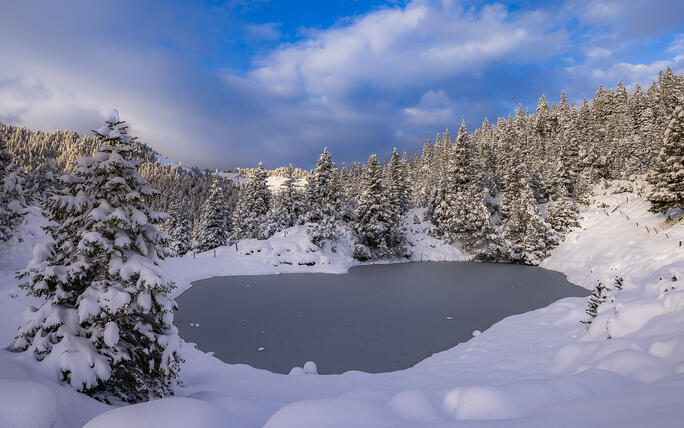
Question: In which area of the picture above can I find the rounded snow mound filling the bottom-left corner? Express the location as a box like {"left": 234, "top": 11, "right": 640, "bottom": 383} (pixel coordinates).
{"left": 0, "top": 379, "right": 57, "bottom": 428}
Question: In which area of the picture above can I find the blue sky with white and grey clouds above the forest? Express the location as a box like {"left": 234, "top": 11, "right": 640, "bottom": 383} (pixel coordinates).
{"left": 0, "top": 0, "right": 684, "bottom": 169}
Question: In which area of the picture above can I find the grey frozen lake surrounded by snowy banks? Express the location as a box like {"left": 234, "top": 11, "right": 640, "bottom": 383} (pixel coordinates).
{"left": 176, "top": 262, "right": 589, "bottom": 374}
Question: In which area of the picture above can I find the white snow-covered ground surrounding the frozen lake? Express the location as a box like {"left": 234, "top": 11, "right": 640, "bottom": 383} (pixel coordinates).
{"left": 0, "top": 183, "right": 684, "bottom": 428}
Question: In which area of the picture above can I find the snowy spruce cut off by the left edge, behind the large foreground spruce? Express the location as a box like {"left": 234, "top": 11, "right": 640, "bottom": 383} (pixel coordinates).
{"left": 0, "top": 137, "right": 26, "bottom": 241}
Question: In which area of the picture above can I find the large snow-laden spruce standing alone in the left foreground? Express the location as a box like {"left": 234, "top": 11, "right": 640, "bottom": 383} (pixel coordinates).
{"left": 11, "top": 110, "right": 181, "bottom": 402}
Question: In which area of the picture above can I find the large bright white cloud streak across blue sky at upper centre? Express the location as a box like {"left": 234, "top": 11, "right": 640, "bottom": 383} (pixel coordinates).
{"left": 250, "top": 1, "right": 566, "bottom": 97}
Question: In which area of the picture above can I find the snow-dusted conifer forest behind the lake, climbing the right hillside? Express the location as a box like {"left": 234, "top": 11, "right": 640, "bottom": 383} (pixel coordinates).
{"left": 187, "top": 68, "right": 684, "bottom": 264}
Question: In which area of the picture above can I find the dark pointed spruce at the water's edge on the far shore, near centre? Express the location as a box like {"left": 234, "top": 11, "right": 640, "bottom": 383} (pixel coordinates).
{"left": 351, "top": 155, "right": 404, "bottom": 260}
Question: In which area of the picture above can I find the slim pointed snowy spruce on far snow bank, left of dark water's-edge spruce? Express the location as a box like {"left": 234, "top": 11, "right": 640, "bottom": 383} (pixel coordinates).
{"left": 306, "top": 147, "right": 343, "bottom": 247}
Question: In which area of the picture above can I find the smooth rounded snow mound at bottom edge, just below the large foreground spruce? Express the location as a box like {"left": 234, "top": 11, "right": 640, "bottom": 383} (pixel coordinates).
{"left": 84, "top": 398, "right": 250, "bottom": 428}
